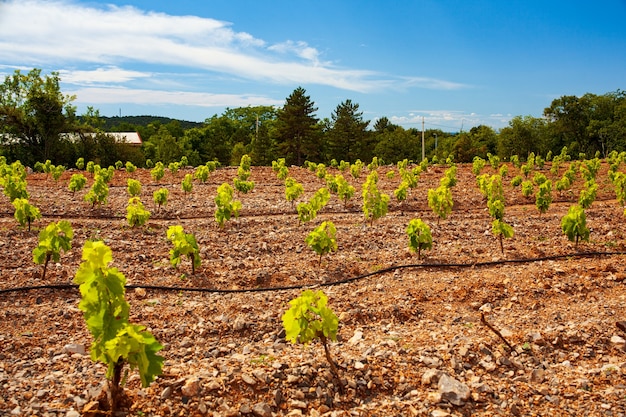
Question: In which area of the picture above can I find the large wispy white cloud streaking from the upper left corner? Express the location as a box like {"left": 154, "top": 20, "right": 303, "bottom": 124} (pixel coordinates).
{"left": 0, "top": 0, "right": 463, "bottom": 93}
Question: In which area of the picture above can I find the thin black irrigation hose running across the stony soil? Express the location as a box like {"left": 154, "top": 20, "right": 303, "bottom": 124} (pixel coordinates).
{"left": 0, "top": 251, "right": 626, "bottom": 295}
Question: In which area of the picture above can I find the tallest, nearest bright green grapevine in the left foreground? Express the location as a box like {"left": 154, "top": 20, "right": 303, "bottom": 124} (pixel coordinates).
{"left": 74, "top": 241, "right": 164, "bottom": 395}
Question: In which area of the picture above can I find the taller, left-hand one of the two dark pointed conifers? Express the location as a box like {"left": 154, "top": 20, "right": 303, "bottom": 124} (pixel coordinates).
{"left": 276, "top": 87, "right": 320, "bottom": 165}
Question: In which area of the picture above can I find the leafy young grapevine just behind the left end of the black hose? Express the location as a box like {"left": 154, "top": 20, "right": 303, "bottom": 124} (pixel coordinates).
{"left": 33, "top": 220, "right": 74, "bottom": 279}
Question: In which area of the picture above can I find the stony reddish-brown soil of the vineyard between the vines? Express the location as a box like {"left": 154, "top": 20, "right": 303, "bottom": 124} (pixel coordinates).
{"left": 0, "top": 164, "right": 626, "bottom": 417}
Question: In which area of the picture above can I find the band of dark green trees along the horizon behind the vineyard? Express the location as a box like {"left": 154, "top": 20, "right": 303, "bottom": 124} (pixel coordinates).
{"left": 0, "top": 69, "right": 626, "bottom": 166}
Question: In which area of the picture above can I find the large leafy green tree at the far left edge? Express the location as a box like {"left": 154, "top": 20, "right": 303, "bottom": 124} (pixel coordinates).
{"left": 0, "top": 69, "right": 76, "bottom": 164}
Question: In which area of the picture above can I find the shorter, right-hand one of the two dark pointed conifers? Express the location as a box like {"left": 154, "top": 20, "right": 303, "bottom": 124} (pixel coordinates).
{"left": 327, "top": 100, "right": 373, "bottom": 162}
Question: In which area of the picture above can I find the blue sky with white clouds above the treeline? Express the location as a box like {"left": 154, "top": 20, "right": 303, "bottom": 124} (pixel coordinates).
{"left": 0, "top": 0, "right": 626, "bottom": 132}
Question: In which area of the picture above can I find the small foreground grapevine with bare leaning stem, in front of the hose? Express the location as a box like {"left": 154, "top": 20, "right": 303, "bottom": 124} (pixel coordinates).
{"left": 282, "top": 290, "right": 339, "bottom": 378}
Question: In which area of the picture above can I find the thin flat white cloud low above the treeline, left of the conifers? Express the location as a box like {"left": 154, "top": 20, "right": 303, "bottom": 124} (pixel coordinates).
{"left": 68, "top": 87, "right": 283, "bottom": 107}
